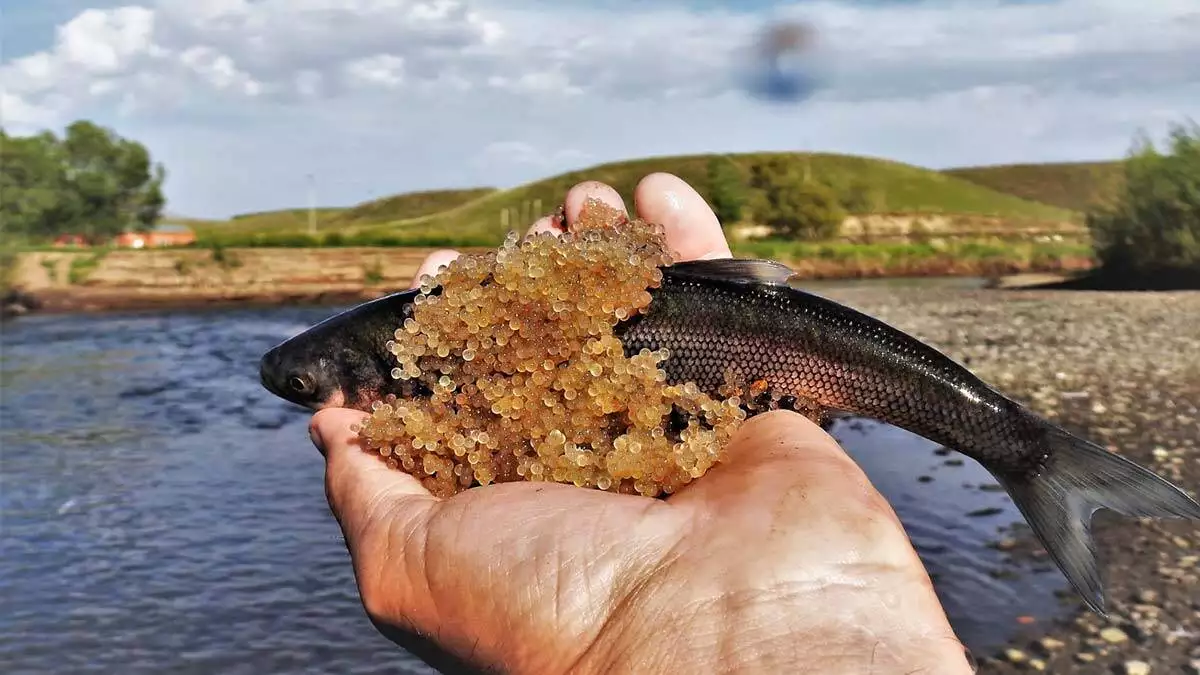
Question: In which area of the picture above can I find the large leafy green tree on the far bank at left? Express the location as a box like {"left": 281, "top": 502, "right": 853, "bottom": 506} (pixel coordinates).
{"left": 0, "top": 120, "right": 166, "bottom": 239}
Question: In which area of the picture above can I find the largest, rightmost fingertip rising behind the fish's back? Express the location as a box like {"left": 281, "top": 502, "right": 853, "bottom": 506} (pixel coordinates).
{"left": 634, "top": 173, "right": 733, "bottom": 262}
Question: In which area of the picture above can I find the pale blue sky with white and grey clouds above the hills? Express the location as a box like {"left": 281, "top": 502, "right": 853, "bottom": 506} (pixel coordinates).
{"left": 0, "top": 0, "right": 1200, "bottom": 217}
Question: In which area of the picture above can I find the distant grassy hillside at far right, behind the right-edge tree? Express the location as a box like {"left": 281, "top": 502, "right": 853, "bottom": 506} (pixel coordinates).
{"left": 942, "top": 162, "right": 1124, "bottom": 211}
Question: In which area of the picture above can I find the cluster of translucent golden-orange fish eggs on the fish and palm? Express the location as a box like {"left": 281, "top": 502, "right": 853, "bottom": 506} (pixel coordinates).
{"left": 358, "top": 201, "right": 745, "bottom": 496}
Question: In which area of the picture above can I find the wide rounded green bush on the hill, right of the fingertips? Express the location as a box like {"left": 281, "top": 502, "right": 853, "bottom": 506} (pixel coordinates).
{"left": 750, "top": 160, "right": 846, "bottom": 240}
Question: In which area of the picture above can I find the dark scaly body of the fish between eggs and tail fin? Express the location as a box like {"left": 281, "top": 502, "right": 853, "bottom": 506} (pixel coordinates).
{"left": 617, "top": 264, "right": 1045, "bottom": 474}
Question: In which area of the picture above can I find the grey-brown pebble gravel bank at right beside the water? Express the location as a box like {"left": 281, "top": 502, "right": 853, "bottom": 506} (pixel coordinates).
{"left": 826, "top": 288, "right": 1200, "bottom": 675}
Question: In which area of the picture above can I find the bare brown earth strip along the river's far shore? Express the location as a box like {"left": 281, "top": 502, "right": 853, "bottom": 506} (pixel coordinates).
{"left": 0, "top": 249, "right": 1092, "bottom": 319}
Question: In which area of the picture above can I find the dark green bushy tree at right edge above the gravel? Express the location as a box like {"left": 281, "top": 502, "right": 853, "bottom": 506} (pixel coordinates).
{"left": 1087, "top": 124, "right": 1200, "bottom": 276}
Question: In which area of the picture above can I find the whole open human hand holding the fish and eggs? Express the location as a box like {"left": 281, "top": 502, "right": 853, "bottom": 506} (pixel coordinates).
{"left": 311, "top": 174, "right": 971, "bottom": 674}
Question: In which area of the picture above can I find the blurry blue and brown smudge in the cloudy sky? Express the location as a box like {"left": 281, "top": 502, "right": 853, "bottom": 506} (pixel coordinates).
{"left": 743, "top": 20, "right": 822, "bottom": 103}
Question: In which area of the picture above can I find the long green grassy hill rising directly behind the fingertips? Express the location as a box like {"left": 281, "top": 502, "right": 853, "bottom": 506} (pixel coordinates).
{"left": 350, "top": 153, "right": 1076, "bottom": 244}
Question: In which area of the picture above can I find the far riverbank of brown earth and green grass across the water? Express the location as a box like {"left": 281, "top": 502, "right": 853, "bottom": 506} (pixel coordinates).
{"left": 0, "top": 241, "right": 1092, "bottom": 312}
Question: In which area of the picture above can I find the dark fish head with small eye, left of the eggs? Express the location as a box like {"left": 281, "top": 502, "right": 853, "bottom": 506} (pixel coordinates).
{"left": 259, "top": 292, "right": 415, "bottom": 411}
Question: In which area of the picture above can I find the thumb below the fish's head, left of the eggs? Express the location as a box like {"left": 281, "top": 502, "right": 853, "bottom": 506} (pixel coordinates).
{"left": 308, "top": 408, "right": 438, "bottom": 530}
